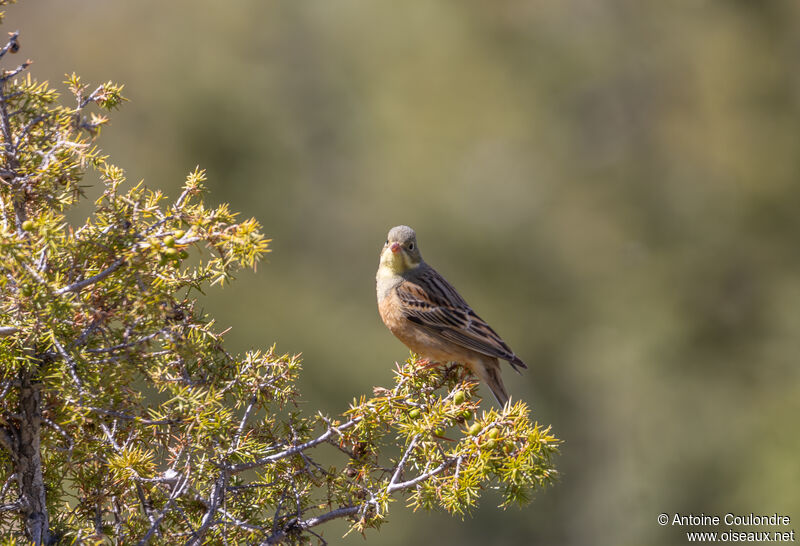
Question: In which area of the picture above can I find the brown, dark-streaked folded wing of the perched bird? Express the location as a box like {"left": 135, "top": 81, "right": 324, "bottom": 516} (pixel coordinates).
{"left": 396, "top": 264, "right": 528, "bottom": 370}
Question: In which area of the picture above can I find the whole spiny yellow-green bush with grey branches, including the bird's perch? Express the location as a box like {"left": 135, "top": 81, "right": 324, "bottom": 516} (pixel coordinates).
{"left": 0, "top": 21, "right": 558, "bottom": 544}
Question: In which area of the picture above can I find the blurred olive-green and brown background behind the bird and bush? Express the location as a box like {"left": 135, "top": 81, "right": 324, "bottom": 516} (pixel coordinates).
{"left": 5, "top": 0, "right": 800, "bottom": 546}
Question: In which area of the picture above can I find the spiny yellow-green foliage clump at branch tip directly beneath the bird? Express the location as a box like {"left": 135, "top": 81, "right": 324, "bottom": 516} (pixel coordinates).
{"left": 341, "top": 359, "right": 559, "bottom": 529}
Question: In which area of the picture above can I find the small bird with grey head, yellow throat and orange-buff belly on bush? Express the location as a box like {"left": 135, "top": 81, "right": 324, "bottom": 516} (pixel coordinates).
{"left": 375, "top": 225, "right": 528, "bottom": 406}
